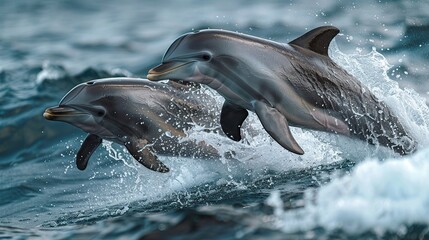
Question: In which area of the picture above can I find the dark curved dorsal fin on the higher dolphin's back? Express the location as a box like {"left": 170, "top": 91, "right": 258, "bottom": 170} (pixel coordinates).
{"left": 289, "top": 26, "right": 340, "bottom": 56}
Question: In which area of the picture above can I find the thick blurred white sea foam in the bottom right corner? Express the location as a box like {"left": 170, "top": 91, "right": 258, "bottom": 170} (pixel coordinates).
{"left": 269, "top": 148, "right": 429, "bottom": 233}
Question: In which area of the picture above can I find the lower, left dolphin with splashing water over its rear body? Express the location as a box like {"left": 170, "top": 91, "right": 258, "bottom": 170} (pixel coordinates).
{"left": 43, "top": 78, "right": 218, "bottom": 172}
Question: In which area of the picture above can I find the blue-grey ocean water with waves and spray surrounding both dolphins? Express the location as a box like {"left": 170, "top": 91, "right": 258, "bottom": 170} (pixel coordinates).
{"left": 0, "top": 0, "right": 429, "bottom": 239}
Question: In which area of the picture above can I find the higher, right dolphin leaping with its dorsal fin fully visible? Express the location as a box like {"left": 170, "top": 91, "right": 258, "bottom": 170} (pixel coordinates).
{"left": 147, "top": 26, "right": 417, "bottom": 155}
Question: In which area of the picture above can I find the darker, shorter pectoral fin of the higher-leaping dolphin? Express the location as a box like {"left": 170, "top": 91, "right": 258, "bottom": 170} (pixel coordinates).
{"left": 220, "top": 101, "right": 249, "bottom": 141}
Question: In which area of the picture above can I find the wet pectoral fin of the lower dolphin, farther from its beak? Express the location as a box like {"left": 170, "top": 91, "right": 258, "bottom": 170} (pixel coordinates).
{"left": 125, "top": 139, "right": 170, "bottom": 173}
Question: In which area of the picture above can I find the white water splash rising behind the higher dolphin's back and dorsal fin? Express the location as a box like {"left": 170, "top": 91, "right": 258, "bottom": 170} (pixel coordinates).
{"left": 330, "top": 42, "right": 429, "bottom": 148}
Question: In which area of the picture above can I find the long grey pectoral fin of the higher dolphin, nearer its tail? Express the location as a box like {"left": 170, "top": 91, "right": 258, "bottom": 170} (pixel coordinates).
{"left": 253, "top": 101, "right": 304, "bottom": 155}
